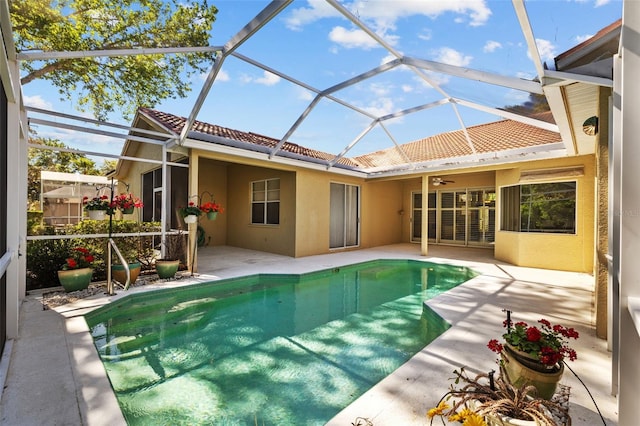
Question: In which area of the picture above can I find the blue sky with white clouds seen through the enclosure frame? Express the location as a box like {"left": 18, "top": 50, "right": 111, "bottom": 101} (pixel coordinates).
{"left": 23, "top": 0, "right": 622, "bottom": 161}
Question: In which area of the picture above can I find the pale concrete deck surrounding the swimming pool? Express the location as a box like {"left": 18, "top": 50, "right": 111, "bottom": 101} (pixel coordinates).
{"left": 0, "top": 244, "right": 618, "bottom": 426}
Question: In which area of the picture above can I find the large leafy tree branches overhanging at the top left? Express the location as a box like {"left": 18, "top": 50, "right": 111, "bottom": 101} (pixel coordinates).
{"left": 10, "top": 0, "right": 218, "bottom": 120}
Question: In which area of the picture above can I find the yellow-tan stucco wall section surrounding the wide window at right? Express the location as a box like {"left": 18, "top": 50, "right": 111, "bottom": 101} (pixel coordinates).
{"left": 494, "top": 156, "right": 595, "bottom": 273}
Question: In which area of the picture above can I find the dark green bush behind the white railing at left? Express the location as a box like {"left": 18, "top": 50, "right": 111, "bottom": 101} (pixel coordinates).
{"left": 27, "top": 220, "right": 160, "bottom": 290}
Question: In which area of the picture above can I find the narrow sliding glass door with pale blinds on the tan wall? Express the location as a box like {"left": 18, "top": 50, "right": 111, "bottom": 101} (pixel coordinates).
{"left": 329, "top": 183, "right": 360, "bottom": 248}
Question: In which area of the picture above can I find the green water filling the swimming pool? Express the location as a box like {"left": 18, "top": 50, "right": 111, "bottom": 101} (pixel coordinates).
{"left": 86, "top": 260, "right": 475, "bottom": 425}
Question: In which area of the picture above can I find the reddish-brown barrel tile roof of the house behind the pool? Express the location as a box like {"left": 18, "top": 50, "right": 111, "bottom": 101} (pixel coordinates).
{"left": 140, "top": 108, "right": 562, "bottom": 169}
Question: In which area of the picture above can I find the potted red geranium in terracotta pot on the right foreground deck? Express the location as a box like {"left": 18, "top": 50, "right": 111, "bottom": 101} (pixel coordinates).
{"left": 487, "top": 311, "right": 579, "bottom": 399}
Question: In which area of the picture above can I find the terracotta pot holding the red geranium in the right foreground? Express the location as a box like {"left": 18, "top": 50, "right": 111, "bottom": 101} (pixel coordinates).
{"left": 501, "top": 347, "right": 564, "bottom": 399}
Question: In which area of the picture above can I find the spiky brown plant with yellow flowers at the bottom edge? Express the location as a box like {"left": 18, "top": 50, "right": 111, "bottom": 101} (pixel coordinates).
{"left": 427, "top": 368, "right": 570, "bottom": 426}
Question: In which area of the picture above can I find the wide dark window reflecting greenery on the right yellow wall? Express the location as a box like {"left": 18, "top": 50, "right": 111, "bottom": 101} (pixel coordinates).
{"left": 500, "top": 182, "right": 576, "bottom": 234}
